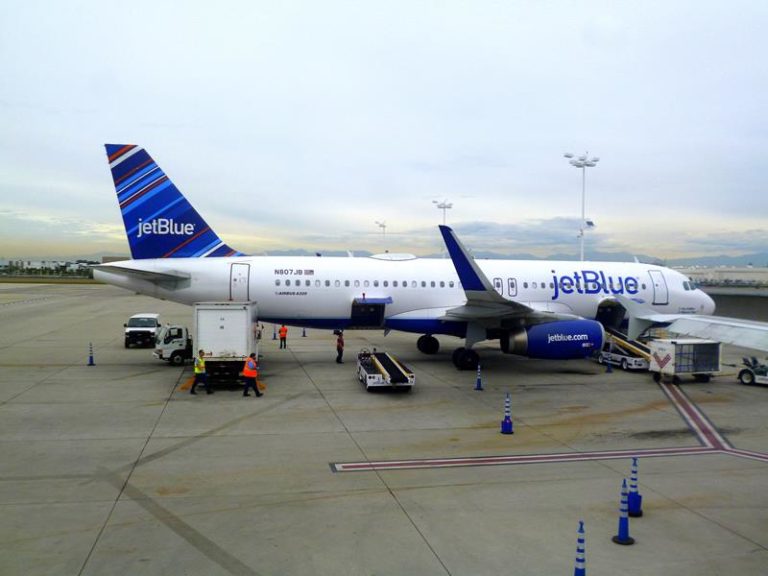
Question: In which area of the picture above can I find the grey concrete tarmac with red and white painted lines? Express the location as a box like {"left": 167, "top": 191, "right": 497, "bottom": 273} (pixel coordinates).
{"left": 0, "top": 284, "right": 768, "bottom": 576}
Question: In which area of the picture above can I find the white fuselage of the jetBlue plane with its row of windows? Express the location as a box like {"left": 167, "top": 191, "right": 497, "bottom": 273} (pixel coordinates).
{"left": 94, "top": 256, "right": 714, "bottom": 333}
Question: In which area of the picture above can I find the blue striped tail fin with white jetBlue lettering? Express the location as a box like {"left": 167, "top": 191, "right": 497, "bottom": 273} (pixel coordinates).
{"left": 105, "top": 144, "right": 242, "bottom": 259}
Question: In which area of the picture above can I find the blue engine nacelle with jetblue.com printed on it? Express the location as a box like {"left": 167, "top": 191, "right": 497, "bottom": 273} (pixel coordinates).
{"left": 500, "top": 320, "right": 605, "bottom": 360}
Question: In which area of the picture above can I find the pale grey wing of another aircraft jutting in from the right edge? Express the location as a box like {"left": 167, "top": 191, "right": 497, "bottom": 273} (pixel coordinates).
{"left": 617, "top": 296, "right": 768, "bottom": 352}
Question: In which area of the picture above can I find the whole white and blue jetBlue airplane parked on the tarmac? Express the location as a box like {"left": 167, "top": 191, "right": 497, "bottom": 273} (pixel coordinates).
{"left": 94, "top": 144, "right": 756, "bottom": 369}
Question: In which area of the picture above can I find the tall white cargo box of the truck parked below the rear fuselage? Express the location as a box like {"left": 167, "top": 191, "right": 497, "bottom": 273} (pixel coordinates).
{"left": 192, "top": 302, "right": 259, "bottom": 383}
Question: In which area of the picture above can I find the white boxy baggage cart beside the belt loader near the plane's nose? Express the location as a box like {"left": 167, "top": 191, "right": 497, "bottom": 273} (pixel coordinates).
{"left": 648, "top": 338, "right": 720, "bottom": 382}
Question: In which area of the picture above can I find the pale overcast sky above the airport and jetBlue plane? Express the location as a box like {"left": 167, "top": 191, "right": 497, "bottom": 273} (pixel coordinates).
{"left": 0, "top": 0, "right": 768, "bottom": 259}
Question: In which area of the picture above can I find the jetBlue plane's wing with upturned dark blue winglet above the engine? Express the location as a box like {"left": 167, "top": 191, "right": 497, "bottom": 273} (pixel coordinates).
{"left": 440, "top": 226, "right": 579, "bottom": 327}
